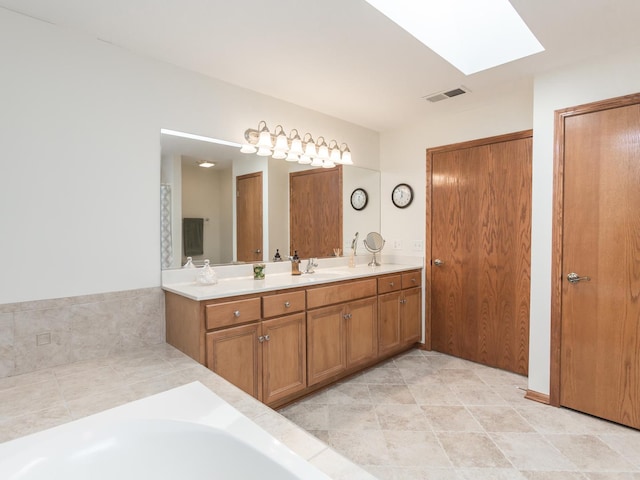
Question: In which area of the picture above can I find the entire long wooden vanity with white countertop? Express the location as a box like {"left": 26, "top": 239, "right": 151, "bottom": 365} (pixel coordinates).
{"left": 163, "top": 262, "right": 422, "bottom": 407}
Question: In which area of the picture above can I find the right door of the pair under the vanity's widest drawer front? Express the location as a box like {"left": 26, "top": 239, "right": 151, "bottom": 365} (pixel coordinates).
{"left": 345, "top": 297, "right": 378, "bottom": 368}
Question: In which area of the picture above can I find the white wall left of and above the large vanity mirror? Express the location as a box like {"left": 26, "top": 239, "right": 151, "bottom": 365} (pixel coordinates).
{"left": 0, "top": 10, "right": 379, "bottom": 304}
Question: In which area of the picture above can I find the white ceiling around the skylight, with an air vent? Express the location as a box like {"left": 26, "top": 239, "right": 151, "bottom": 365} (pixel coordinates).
{"left": 0, "top": 0, "right": 640, "bottom": 131}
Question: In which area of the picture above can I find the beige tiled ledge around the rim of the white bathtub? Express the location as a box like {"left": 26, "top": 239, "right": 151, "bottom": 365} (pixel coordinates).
{"left": 0, "top": 343, "right": 374, "bottom": 480}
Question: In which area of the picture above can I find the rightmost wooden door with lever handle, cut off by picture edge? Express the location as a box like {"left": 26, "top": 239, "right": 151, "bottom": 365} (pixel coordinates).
{"left": 560, "top": 104, "right": 640, "bottom": 428}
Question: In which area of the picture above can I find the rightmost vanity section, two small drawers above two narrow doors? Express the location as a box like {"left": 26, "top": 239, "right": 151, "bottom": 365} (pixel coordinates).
{"left": 378, "top": 271, "right": 422, "bottom": 355}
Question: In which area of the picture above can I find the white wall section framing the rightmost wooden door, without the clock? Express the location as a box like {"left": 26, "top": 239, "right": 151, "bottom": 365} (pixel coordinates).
{"left": 529, "top": 47, "right": 640, "bottom": 393}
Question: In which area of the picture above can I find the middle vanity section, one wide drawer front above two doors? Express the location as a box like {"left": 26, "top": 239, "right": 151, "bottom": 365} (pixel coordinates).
{"left": 307, "top": 279, "right": 378, "bottom": 386}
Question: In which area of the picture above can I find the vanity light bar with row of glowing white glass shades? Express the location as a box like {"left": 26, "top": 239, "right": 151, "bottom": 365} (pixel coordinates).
{"left": 240, "top": 120, "right": 353, "bottom": 168}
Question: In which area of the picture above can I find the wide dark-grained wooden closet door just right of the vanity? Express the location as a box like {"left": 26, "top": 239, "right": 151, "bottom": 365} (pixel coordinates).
{"left": 427, "top": 131, "right": 532, "bottom": 374}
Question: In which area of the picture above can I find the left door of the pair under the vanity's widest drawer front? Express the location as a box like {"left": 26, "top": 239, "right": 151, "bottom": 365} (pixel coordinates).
{"left": 307, "top": 305, "right": 347, "bottom": 386}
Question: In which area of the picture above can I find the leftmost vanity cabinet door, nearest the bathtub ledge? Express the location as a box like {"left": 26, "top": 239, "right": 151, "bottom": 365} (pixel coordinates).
{"left": 206, "top": 323, "right": 262, "bottom": 399}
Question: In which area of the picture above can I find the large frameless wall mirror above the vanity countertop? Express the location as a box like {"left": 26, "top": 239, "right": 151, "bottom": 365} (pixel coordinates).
{"left": 160, "top": 129, "right": 380, "bottom": 269}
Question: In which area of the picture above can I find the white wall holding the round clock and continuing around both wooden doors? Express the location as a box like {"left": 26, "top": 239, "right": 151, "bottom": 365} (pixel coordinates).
{"left": 380, "top": 48, "right": 640, "bottom": 394}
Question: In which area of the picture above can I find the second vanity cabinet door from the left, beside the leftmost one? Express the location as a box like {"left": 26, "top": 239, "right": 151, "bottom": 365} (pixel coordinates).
{"left": 262, "top": 313, "right": 307, "bottom": 405}
